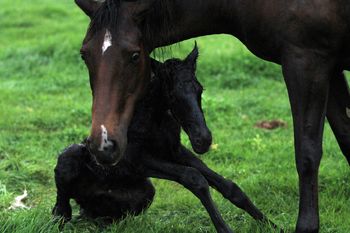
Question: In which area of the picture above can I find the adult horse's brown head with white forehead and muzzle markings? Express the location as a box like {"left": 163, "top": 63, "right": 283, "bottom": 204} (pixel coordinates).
{"left": 75, "top": 0, "right": 154, "bottom": 165}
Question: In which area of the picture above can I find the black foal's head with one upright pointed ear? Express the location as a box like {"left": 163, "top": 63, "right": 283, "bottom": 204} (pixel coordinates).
{"left": 164, "top": 45, "right": 212, "bottom": 154}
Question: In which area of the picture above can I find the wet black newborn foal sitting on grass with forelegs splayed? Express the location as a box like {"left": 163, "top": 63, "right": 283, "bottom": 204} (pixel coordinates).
{"left": 53, "top": 47, "right": 272, "bottom": 232}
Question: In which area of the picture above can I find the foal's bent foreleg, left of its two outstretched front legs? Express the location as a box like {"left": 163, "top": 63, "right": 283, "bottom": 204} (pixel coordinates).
{"left": 142, "top": 156, "right": 232, "bottom": 233}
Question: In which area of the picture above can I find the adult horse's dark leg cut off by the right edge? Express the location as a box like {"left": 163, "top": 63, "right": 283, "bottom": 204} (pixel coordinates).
{"left": 327, "top": 72, "right": 350, "bottom": 164}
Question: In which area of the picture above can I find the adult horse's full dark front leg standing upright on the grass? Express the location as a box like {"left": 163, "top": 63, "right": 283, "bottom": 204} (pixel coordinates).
{"left": 282, "top": 46, "right": 334, "bottom": 233}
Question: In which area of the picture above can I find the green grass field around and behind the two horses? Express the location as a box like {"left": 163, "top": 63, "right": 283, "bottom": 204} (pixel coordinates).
{"left": 0, "top": 0, "right": 350, "bottom": 233}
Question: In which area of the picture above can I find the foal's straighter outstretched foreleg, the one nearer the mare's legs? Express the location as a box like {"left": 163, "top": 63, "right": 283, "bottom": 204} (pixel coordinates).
{"left": 179, "top": 146, "right": 276, "bottom": 227}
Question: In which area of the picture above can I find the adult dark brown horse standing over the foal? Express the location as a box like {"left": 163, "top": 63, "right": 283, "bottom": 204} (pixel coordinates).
{"left": 76, "top": 0, "right": 350, "bottom": 232}
